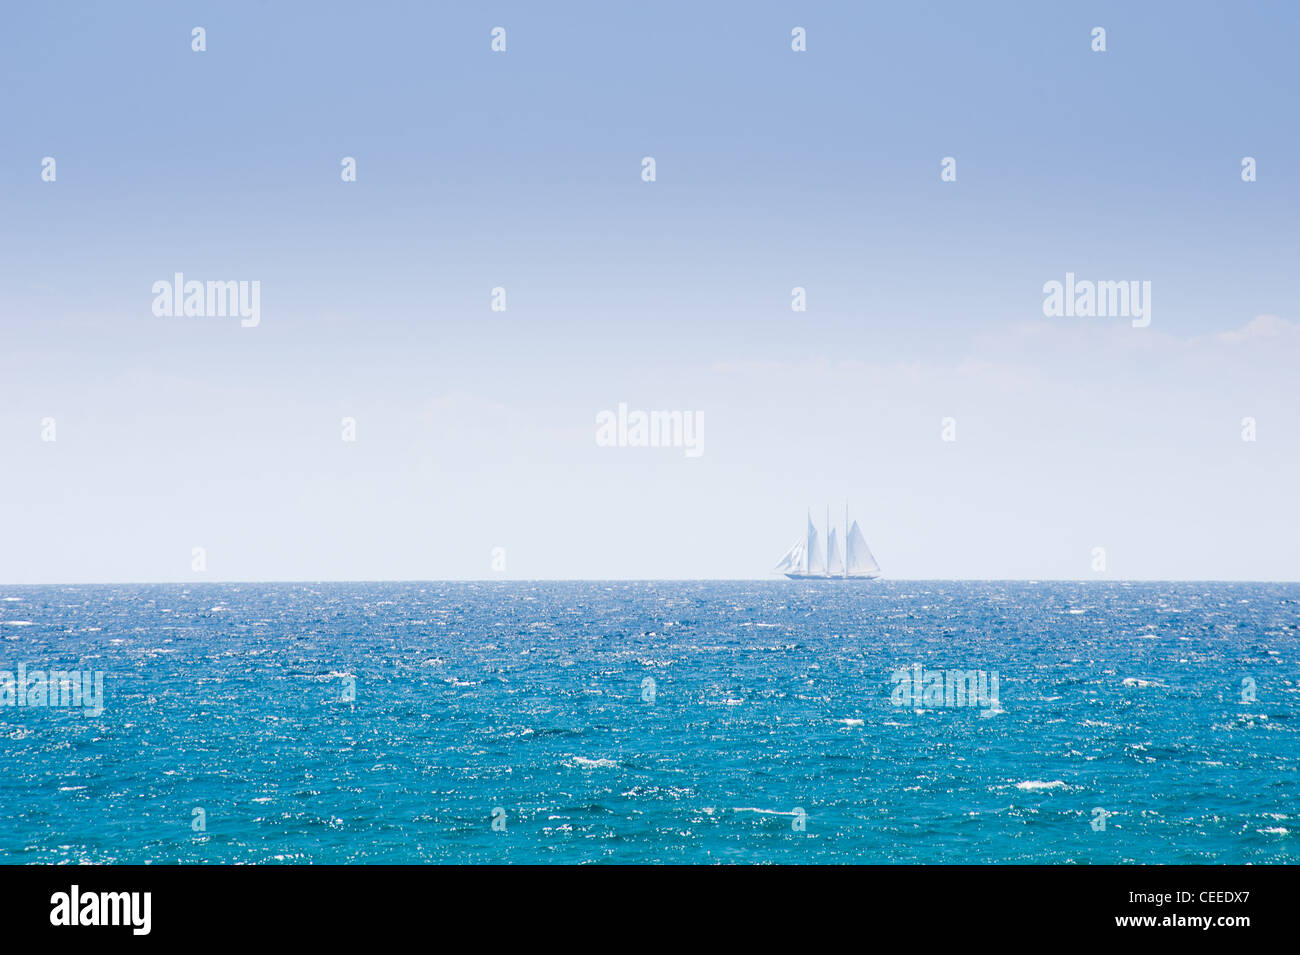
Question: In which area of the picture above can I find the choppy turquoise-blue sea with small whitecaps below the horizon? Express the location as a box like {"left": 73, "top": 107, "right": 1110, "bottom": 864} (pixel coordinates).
{"left": 0, "top": 581, "right": 1300, "bottom": 863}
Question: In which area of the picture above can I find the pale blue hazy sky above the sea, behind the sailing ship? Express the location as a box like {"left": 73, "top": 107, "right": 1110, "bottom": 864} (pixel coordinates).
{"left": 0, "top": 1, "right": 1300, "bottom": 583}
